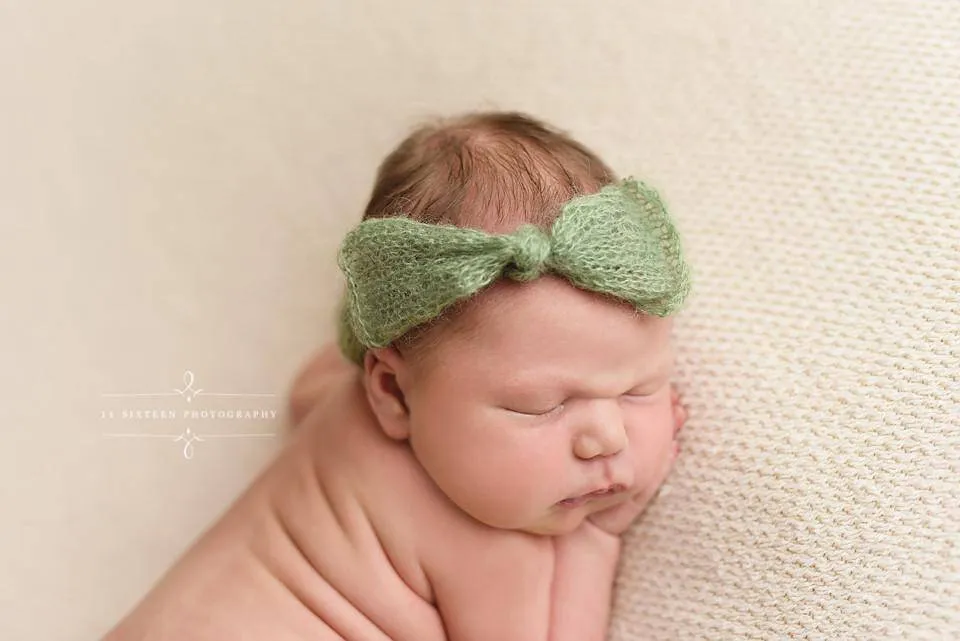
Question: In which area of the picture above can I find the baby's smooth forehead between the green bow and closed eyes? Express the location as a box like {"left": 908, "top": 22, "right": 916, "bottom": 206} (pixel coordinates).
{"left": 420, "top": 276, "right": 671, "bottom": 384}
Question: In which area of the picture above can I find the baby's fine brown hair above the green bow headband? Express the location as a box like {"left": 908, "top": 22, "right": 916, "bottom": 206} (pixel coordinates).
{"left": 363, "top": 111, "right": 617, "bottom": 233}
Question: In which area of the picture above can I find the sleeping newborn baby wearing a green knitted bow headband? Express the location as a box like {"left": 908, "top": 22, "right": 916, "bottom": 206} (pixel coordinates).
{"left": 105, "top": 113, "right": 689, "bottom": 641}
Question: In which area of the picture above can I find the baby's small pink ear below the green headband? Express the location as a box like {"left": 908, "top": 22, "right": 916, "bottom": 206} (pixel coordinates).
{"left": 363, "top": 346, "right": 410, "bottom": 441}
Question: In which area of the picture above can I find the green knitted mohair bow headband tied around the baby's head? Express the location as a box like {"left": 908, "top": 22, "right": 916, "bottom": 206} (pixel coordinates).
{"left": 338, "top": 179, "right": 691, "bottom": 363}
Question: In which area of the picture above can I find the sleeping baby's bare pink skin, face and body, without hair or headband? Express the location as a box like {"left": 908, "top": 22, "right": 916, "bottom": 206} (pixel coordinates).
{"left": 104, "top": 277, "right": 686, "bottom": 641}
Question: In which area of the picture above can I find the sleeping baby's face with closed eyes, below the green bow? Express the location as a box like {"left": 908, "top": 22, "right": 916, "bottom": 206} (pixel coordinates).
{"left": 398, "top": 277, "right": 674, "bottom": 534}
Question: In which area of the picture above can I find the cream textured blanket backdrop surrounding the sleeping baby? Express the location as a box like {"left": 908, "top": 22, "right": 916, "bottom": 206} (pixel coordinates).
{"left": 0, "top": 0, "right": 960, "bottom": 641}
